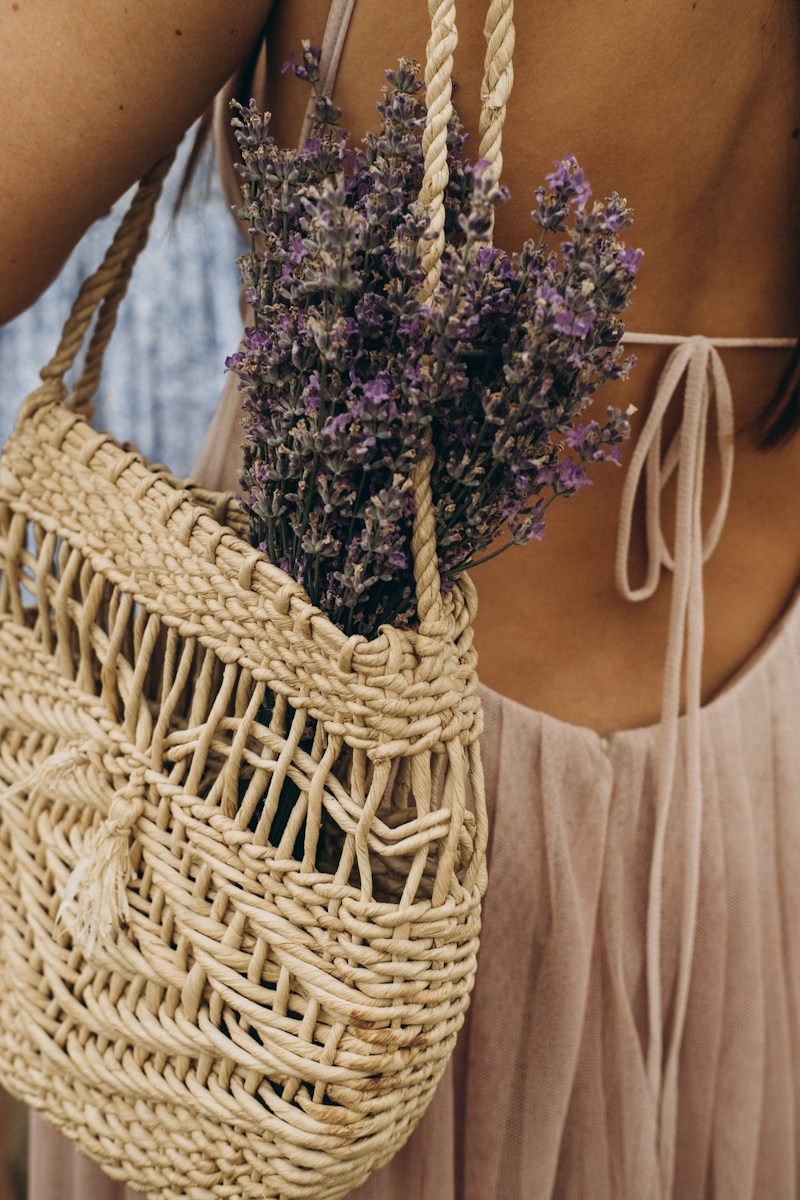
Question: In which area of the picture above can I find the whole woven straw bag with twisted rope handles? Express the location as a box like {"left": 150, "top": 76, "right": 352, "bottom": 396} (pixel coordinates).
{"left": 0, "top": 0, "right": 513, "bottom": 1200}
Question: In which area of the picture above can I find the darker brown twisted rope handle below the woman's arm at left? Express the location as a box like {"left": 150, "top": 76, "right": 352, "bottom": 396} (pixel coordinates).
{"left": 18, "top": 151, "right": 175, "bottom": 421}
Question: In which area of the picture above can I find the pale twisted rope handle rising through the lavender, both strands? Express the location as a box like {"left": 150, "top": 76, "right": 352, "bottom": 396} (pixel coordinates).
{"left": 411, "top": 0, "right": 515, "bottom": 657}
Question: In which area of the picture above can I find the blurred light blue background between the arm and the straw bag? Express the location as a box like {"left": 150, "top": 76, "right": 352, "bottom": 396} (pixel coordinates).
{"left": 0, "top": 130, "right": 245, "bottom": 1200}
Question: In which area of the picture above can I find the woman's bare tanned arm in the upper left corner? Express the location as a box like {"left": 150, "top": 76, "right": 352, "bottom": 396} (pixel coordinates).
{"left": 0, "top": 0, "right": 273, "bottom": 324}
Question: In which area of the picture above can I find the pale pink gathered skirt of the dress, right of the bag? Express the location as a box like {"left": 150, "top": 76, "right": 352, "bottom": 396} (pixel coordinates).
{"left": 353, "top": 601, "right": 800, "bottom": 1200}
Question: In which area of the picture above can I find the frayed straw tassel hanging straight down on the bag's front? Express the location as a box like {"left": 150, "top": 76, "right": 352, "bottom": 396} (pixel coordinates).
{"left": 55, "top": 769, "right": 144, "bottom": 958}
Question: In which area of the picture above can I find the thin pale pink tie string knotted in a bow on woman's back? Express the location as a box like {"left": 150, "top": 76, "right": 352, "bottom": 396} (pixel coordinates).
{"left": 615, "top": 332, "right": 794, "bottom": 1200}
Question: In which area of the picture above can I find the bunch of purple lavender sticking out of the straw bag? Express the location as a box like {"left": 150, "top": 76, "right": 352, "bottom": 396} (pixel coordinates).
{"left": 227, "top": 42, "right": 642, "bottom": 637}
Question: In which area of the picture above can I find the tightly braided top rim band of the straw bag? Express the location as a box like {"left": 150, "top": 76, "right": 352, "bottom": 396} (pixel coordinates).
{"left": 0, "top": 406, "right": 482, "bottom": 757}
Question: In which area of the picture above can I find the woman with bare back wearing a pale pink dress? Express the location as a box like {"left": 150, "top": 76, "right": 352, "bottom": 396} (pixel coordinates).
{"left": 0, "top": 0, "right": 800, "bottom": 1200}
